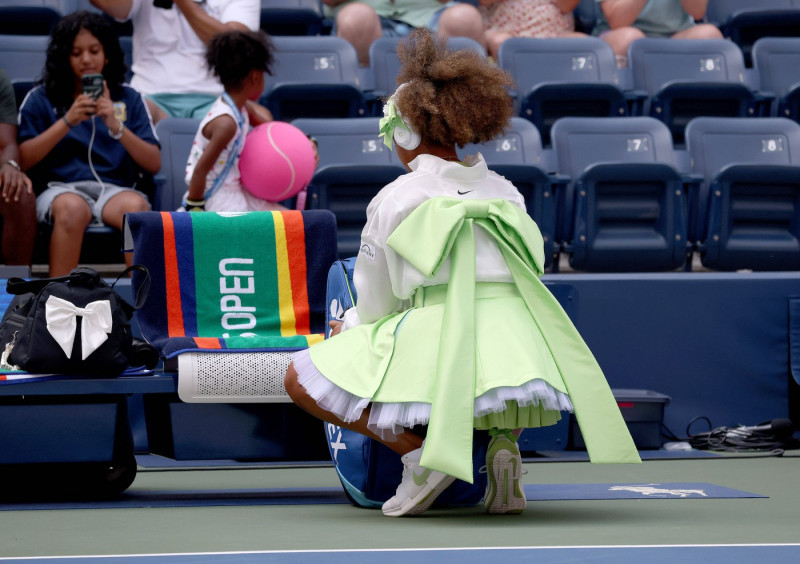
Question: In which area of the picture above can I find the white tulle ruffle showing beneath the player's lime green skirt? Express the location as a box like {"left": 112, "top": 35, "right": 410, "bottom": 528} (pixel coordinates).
{"left": 292, "top": 349, "right": 572, "bottom": 441}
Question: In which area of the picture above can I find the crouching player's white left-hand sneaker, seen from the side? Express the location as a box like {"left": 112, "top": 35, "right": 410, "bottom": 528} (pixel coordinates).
{"left": 383, "top": 448, "right": 455, "bottom": 517}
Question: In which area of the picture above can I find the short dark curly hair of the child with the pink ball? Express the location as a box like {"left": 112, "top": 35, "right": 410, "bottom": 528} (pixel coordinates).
{"left": 206, "top": 30, "right": 274, "bottom": 90}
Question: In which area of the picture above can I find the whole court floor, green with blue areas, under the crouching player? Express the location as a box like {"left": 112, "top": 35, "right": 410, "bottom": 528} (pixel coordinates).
{"left": 0, "top": 451, "right": 800, "bottom": 564}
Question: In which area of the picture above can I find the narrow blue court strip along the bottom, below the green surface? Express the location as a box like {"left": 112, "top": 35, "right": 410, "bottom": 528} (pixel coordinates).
{"left": 0, "top": 544, "right": 800, "bottom": 564}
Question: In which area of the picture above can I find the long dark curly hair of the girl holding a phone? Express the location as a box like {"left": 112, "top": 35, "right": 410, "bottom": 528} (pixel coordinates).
{"left": 39, "top": 10, "right": 127, "bottom": 114}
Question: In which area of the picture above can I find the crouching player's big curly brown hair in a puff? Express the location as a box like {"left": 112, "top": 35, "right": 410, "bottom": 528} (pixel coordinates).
{"left": 395, "top": 29, "right": 513, "bottom": 147}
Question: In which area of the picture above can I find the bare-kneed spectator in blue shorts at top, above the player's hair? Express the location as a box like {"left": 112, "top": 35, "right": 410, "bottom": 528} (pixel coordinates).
{"left": 322, "top": 0, "right": 485, "bottom": 67}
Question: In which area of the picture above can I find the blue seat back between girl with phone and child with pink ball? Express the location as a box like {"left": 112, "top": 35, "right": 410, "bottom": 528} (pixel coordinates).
{"left": 153, "top": 118, "right": 200, "bottom": 211}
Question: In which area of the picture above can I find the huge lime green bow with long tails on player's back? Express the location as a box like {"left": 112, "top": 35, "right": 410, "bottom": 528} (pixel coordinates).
{"left": 387, "top": 197, "right": 639, "bottom": 483}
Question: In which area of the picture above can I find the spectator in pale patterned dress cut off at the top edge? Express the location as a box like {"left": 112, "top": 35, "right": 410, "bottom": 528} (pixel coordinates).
{"left": 480, "top": 0, "right": 585, "bottom": 59}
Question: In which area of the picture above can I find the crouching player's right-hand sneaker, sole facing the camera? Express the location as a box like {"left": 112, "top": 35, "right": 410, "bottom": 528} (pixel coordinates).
{"left": 483, "top": 431, "right": 526, "bottom": 514}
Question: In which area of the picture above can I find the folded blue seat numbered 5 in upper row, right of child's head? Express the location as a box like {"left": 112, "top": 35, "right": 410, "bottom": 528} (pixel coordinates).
{"left": 259, "top": 36, "right": 367, "bottom": 121}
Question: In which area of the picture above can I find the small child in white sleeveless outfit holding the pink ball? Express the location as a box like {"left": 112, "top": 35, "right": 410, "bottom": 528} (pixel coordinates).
{"left": 184, "top": 30, "right": 313, "bottom": 211}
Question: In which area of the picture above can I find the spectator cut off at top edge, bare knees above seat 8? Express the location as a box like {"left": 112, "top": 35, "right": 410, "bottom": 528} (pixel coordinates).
{"left": 592, "top": 0, "right": 722, "bottom": 67}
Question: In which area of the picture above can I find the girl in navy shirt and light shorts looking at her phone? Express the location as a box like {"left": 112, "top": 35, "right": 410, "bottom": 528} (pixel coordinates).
{"left": 19, "top": 11, "right": 161, "bottom": 276}
